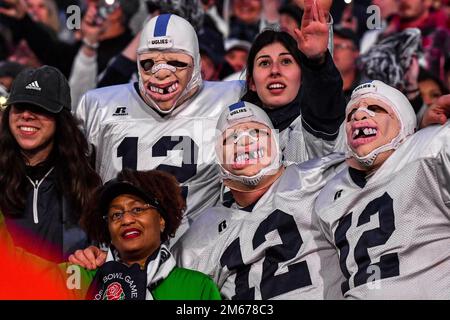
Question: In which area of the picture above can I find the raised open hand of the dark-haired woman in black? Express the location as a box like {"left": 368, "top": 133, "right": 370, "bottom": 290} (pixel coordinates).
{"left": 294, "top": 0, "right": 329, "bottom": 60}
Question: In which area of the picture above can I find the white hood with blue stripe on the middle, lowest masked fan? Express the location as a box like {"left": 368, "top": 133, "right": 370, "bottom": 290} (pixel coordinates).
{"left": 216, "top": 101, "right": 282, "bottom": 186}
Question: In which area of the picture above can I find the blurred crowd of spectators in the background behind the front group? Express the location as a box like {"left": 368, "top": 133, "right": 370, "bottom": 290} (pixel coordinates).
{"left": 0, "top": 0, "right": 450, "bottom": 109}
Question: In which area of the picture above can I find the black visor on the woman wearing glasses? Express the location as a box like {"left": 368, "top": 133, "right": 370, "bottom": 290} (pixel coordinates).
{"left": 99, "top": 178, "right": 164, "bottom": 216}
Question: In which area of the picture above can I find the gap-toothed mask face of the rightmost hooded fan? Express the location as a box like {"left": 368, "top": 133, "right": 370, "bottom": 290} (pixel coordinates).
{"left": 346, "top": 98, "right": 401, "bottom": 157}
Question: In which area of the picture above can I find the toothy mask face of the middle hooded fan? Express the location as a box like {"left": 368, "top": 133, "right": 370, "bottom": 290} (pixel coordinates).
{"left": 220, "top": 122, "right": 274, "bottom": 177}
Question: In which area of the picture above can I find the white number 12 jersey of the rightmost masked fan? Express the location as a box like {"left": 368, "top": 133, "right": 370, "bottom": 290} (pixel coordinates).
{"left": 315, "top": 123, "right": 450, "bottom": 299}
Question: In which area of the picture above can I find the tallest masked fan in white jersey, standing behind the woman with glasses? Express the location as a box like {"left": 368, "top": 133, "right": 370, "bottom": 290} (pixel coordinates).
{"left": 76, "top": 14, "right": 243, "bottom": 239}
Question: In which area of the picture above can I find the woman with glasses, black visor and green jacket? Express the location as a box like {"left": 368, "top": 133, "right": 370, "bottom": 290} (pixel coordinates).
{"left": 71, "top": 169, "right": 220, "bottom": 300}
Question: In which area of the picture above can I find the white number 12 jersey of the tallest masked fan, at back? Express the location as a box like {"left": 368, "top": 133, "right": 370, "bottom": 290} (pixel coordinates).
{"left": 75, "top": 81, "right": 243, "bottom": 240}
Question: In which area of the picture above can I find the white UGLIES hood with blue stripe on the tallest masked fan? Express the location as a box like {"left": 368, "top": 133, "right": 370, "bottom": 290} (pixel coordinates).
{"left": 137, "top": 14, "right": 202, "bottom": 114}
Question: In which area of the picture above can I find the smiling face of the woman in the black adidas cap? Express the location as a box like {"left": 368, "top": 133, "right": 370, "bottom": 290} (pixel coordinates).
{"left": 9, "top": 104, "right": 56, "bottom": 165}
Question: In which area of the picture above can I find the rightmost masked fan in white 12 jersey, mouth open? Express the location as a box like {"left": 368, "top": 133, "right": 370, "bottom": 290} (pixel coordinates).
{"left": 314, "top": 81, "right": 450, "bottom": 299}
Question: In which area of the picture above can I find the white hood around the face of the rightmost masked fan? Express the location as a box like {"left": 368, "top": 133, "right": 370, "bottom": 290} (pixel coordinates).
{"left": 346, "top": 80, "right": 417, "bottom": 167}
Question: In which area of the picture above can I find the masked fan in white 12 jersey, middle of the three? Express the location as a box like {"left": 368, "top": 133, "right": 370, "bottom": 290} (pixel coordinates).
{"left": 173, "top": 102, "right": 344, "bottom": 300}
